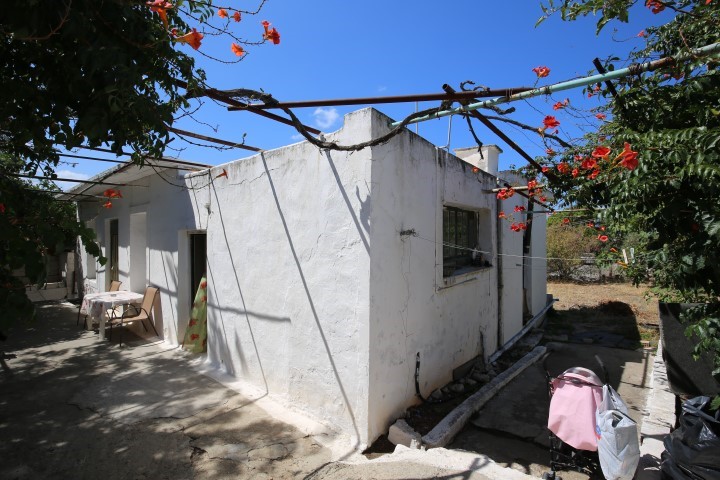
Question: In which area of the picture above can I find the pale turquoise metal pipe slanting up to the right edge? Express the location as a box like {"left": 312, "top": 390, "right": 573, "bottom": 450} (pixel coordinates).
{"left": 390, "top": 43, "right": 720, "bottom": 127}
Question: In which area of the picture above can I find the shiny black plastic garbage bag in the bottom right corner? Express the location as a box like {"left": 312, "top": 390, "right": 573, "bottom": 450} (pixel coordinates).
{"left": 661, "top": 397, "right": 720, "bottom": 480}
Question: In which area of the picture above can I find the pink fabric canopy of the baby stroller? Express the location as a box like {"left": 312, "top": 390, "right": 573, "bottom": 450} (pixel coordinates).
{"left": 548, "top": 367, "right": 602, "bottom": 452}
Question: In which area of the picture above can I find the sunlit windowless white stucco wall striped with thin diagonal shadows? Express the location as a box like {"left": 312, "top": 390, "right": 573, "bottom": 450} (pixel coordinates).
{"left": 188, "top": 110, "right": 371, "bottom": 446}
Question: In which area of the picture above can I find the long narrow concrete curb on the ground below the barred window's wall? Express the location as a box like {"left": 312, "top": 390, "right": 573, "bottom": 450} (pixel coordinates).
{"left": 422, "top": 346, "right": 546, "bottom": 448}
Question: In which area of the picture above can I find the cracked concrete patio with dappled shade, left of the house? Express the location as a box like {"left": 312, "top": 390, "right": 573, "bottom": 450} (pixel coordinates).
{"left": 0, "top": 303, "right": 331, "bottom": 480}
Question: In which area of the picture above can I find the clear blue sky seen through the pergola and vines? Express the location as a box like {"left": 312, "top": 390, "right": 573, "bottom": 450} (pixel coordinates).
{"left": 58, "top": 0, "right": 669, "bottom": 187}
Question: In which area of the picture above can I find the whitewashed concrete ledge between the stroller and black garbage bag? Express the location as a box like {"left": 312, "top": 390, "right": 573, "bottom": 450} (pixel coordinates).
{"left": 635, "top": 344, "right": 675, "bottom": 480}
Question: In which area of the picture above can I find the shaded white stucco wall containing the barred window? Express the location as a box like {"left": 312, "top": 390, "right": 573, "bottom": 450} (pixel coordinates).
{"left": 369, "top": 116, "right": 497, "bottom": 439}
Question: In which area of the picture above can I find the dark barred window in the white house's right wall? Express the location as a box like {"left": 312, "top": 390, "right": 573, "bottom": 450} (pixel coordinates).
{"left": 443, "top": 207, "right": 490, "bottom": 277}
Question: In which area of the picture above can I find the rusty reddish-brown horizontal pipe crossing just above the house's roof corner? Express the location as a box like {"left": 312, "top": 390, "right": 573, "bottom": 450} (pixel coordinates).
{"left": 233, "top": 87, "right": 532, "bottom": 110}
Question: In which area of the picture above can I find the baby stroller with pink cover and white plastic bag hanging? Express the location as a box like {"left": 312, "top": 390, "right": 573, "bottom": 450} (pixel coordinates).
{"left": 543, "top": 355, "right": 640, "bottom": 480}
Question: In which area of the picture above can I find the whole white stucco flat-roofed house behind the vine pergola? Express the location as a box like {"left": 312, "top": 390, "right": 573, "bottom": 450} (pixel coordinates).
{"left": 69, "top": 109, "right": 547, "bottom": 448}
